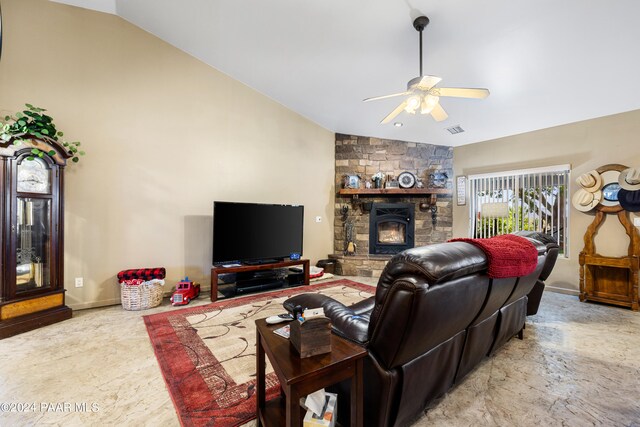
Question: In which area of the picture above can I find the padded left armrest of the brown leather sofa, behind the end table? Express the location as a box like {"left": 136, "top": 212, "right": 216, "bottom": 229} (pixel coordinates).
{"left": 282, "top": 294, "right": 373, "bottom": 345}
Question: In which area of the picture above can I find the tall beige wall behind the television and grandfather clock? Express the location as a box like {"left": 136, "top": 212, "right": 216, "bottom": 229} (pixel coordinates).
{"left": 0, "top": 0, "right": 334, "bottom": 308}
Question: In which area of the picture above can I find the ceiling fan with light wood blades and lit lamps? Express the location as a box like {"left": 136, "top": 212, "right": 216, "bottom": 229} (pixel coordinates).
{"left": 364, "top": 16, "right": 489, "bottom": 124}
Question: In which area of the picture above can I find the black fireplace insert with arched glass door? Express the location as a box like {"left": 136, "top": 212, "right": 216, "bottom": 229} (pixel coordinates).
{"left": 369, "top": 203, "right": 415, "bottom": 255}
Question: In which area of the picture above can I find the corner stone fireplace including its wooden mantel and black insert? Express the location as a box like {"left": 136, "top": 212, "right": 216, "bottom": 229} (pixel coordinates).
{"left": 329, "top": 134, "right": 453, "bottom": 277}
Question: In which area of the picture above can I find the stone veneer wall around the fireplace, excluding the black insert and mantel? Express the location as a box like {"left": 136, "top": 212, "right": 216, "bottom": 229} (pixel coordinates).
{"left": 332, "top": 134, "right": 453, "bottom": 277}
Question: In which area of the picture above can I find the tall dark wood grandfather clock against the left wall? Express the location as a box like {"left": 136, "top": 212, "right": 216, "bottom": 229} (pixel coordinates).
{"left": 0, "top": 138, "right": 72, "bottom": 339}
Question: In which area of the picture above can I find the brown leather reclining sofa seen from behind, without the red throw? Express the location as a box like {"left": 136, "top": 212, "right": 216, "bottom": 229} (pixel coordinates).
{"left": 284, "top": 239, "right": 547, "bottom": 427}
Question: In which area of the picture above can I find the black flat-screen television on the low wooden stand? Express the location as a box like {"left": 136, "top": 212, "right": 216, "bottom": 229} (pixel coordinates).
{"left": 213, "top": 201, "right": 304, "bottom": 264}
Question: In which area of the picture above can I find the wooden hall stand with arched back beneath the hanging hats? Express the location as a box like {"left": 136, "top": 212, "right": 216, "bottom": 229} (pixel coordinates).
{"left": 579, "top": 165, "right": 640, "bottom": 311}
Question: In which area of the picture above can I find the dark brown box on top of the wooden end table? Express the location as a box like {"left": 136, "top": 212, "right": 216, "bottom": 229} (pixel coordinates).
{"left": 289, "top": 316, "right": 331, "bottom": 358}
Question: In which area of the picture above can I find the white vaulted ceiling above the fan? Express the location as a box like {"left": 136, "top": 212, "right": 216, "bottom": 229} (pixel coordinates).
{"left": 55, "top": 0, "right": 640, "bottom": 146}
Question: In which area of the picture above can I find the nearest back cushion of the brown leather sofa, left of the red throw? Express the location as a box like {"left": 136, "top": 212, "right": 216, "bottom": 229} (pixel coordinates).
{"left": 368, "top": 242, "right": 489, "bottom": 369}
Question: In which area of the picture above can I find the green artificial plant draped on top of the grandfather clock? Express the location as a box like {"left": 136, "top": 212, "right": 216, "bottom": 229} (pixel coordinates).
{"left": 0, "top": 104, "right": 84, "bottom": 163}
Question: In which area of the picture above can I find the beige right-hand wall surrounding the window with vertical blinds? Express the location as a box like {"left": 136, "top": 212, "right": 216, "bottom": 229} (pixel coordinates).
{"left": 453, "top": 110, "right": 640, "bottom": 293}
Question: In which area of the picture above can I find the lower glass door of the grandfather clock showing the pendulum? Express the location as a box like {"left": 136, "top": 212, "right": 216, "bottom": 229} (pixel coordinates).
{"left": 16, "top": 197, "right": 51, "bottom": 292}
